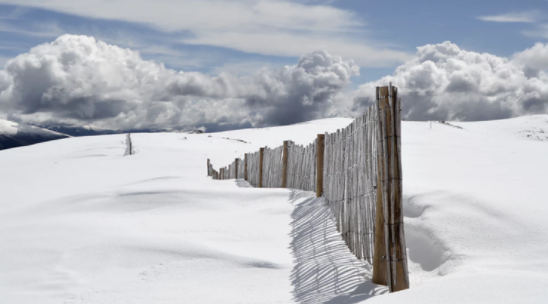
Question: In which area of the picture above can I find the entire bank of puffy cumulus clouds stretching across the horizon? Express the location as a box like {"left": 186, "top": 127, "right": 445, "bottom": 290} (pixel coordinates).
{"left": 0, "top": 35, "right": 548, "bottom": 131}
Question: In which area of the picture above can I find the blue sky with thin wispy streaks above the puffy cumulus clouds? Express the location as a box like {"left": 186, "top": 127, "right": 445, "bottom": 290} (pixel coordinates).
{"left": 0, "top": 0, "right": 548, "bottom": 85}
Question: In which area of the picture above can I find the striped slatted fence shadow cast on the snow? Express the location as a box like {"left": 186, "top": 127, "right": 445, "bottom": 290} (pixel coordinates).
{"left": 289, "top": 190, "right": 388, "bottom": 304}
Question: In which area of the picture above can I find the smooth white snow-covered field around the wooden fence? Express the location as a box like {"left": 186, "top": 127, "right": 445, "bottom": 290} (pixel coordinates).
{"left": 0, "top": 115, "right": 548, "bottom": 303}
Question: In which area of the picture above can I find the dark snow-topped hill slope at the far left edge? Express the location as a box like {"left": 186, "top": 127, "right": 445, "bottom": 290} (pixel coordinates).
{"left": 0, "top": 119, "right": 70, "bottom": 150}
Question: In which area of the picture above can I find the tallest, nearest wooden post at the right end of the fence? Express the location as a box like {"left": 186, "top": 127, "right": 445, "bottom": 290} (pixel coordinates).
{"left": 374, "top": 84, "right": 409, "bottom": 292}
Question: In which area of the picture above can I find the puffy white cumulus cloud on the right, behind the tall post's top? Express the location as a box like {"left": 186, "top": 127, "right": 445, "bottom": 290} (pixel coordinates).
{"left": 353, "top": 42, "right": 548, "bottom": 120}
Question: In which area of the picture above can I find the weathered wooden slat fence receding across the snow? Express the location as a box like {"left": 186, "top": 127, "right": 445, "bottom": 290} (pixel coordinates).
{"left": 207, "top": 85, "right": 409, "bottom": 292}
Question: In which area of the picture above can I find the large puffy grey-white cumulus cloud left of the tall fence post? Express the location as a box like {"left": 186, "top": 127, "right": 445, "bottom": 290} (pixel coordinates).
{"left": 0, "top": 35, "right": 359, "bottom": 128}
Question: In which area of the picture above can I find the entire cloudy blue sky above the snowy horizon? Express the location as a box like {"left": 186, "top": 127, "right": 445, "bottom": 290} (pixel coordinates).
{"left": 0, "top": 0, "right": 548, "bottom": 131}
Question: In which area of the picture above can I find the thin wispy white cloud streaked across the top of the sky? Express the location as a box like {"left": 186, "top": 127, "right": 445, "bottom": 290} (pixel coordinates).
{"left": 0, "top": 0, "right": 410, "bottom": 66}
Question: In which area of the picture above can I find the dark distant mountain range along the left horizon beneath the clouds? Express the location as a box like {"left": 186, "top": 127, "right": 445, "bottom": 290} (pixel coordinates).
{"left": 0, "top": 119, "right": 204, "bottom": 150}
